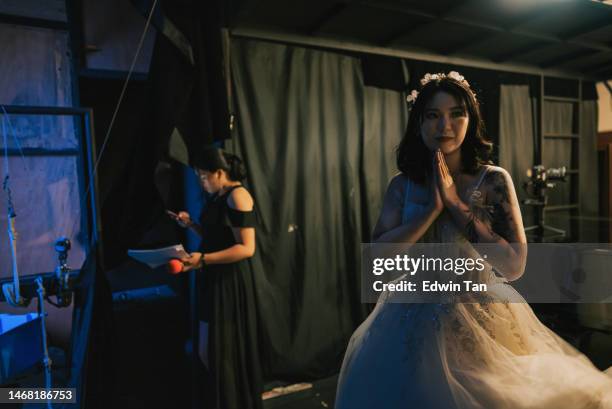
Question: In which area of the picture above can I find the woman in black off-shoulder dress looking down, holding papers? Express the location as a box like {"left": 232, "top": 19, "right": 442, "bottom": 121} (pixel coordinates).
{"left": 169, "top": 148, "right": 262, "bottom": 409}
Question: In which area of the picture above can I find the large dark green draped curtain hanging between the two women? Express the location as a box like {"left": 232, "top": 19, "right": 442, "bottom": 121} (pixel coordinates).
{"left": 228, "top": 39, "right": 406, "bottom": 380}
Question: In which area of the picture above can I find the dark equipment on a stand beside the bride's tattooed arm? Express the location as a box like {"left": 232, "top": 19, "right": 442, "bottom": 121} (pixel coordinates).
{"left": 522, "top": 165, "right": 567, "bottom": 243}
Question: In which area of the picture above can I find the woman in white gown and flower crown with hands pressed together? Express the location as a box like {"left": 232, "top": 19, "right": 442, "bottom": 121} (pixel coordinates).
{"left": 336, "top": 72, "right": 612, "bottom": 409}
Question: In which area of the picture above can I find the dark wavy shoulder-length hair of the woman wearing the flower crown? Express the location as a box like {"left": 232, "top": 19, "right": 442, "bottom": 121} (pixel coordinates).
{"left": 396, "top": 76, "right": 493, "bottom": 185}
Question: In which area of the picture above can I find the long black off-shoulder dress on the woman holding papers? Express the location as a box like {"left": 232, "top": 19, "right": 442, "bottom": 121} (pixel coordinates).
{"left": 198, "top": 186, "right": 262, "bottom": 409}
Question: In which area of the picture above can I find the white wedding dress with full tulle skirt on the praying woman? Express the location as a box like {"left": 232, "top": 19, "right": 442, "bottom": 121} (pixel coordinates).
{"left": 335, "top": 167, "right": 612, "bottom": 409}
